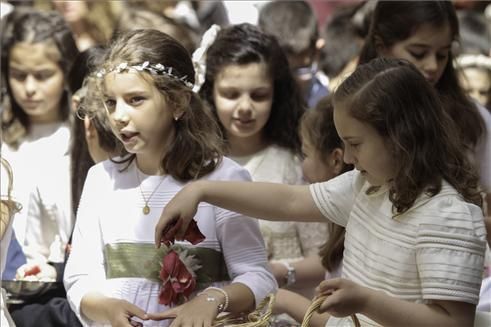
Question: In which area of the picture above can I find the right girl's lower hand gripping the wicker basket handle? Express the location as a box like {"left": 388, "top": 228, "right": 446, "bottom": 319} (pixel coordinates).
{"left": 317, "top": 278, "right": 370, "bottom": 317}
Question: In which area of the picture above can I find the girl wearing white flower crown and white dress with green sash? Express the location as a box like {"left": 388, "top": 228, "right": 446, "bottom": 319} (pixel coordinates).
{"left": 64, "top": 30, "right": 276, "bottom": 326}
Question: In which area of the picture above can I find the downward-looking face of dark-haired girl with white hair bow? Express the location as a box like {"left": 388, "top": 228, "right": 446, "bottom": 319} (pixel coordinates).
{"left": 213, "top": 63, "right": 274, "bottom": 146}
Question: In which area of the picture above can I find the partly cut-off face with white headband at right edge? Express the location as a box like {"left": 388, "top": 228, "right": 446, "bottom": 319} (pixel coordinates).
{"left": 459, "top": 67, "right": 491, "bottom": 106}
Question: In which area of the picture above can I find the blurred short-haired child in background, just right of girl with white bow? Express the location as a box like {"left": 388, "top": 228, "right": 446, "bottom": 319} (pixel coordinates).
{"left": 258, "top": 1, "right": 328, "bottom": 108}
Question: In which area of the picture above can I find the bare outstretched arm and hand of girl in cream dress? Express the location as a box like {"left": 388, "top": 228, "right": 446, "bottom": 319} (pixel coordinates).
{"left": 155, "top": 181, "right": 325, "bottom": 246}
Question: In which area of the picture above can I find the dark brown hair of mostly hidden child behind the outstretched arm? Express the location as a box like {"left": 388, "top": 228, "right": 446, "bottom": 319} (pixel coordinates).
{"left": 300, "top": 96, "right": 353, "bottom": 272}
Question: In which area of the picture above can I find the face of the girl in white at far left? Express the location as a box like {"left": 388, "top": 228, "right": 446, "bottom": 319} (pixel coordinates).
{"left": 8, "top": 42, "right": 65, "bottom": 123}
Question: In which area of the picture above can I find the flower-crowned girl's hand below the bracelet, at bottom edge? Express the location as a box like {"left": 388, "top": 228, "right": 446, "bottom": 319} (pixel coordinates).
{"left": 147, "top": 294, "right": 220, "bottom": 327}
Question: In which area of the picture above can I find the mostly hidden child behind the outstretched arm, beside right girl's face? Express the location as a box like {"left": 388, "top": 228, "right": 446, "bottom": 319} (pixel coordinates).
{"left": 274, "top": 96, "right": 353, "bottom": 326}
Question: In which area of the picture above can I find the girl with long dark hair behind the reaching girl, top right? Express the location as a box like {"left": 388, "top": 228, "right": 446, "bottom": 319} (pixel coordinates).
{"left": 359, "top": 1, "right": 491, "bottom": 233}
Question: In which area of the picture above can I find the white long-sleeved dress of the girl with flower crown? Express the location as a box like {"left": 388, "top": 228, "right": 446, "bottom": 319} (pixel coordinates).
{"left": 64, "top": 158, "right": 277, "bottom": 326}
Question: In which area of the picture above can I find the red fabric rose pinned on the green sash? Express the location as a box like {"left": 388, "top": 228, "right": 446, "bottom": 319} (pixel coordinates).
{"left": 159, "top": 250, "right": 196, "bottom": 305}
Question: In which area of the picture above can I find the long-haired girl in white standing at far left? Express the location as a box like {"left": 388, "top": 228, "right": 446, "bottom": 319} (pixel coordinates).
{"left": 2, "top": 8, "right": 78, "bottom": 275}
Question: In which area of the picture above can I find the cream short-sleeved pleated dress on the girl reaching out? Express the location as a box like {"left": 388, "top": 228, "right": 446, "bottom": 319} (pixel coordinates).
{"left": 310, "top": 171, "right": 486, "bottom": 326}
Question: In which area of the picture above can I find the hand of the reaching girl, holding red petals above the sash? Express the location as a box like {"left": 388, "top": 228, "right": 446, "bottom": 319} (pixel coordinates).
{"left": 155, "top": 182, "right": 201, "bottom": 248}
